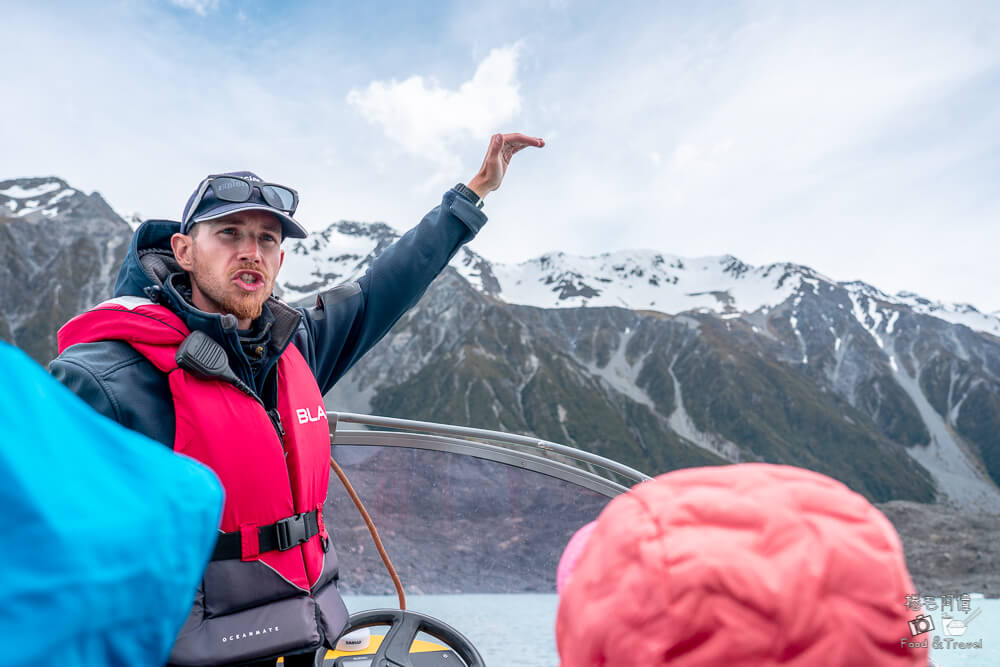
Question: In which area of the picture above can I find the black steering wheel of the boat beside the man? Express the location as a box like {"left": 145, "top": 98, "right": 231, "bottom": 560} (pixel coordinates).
{"left": 341, "top": 609, "right": 486, "bottom": 667}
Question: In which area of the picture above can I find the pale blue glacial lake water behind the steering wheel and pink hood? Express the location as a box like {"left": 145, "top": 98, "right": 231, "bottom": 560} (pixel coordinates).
{"left": 345, "top": 594, "right": 1000, "bottom": 667}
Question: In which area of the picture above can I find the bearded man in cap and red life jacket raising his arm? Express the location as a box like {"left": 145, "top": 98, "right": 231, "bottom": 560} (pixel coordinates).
{"left": 50, "top": 134, "right": 544, "bottom": 665}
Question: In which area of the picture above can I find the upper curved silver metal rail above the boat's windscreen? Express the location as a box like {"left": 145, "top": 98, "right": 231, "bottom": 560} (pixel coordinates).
{"left": 328, "top": 412, "right": 651, "bottom": 482}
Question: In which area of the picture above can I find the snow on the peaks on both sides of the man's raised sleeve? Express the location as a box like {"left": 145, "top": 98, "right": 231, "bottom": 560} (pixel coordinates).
{"left": 281, "top": 222, "right": 1000, "bottom": 341}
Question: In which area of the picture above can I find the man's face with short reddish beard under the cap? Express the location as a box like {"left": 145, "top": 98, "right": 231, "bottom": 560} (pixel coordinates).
{"left": 171, "top": 211, "right": 285, "bottom": 329}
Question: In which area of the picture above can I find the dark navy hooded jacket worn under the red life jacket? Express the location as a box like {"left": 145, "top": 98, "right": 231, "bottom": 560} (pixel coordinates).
{"left": 49, "top": 190, "right": 486, "bottom": 447}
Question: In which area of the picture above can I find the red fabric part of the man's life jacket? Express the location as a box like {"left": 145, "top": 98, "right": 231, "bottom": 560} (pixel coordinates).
{"left": 58, "top": 297, "right": 330, "bottom": 591}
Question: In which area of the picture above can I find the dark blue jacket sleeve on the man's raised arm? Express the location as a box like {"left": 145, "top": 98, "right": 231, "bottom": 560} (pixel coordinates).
{"left": 294, "top": 190, "right": 486, "bottom": 394}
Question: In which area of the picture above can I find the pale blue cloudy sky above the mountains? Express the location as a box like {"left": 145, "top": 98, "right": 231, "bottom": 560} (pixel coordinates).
{"left": 0, "top": 0, "right": 1000, "bottom": 311}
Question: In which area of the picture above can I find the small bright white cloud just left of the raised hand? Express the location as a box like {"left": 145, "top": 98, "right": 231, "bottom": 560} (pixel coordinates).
{"left": 347, "top": 44, "right": 521, "bottom": 172}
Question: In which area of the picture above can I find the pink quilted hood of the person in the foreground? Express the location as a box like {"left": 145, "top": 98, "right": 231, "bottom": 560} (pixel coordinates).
{"left": 556, "top": 463, "right": 927, "bottom": 667}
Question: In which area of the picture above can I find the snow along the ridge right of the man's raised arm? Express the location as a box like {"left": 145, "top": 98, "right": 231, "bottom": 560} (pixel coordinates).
{"left": 453, "top": 245, "right": 1000, "bottom": 340}
